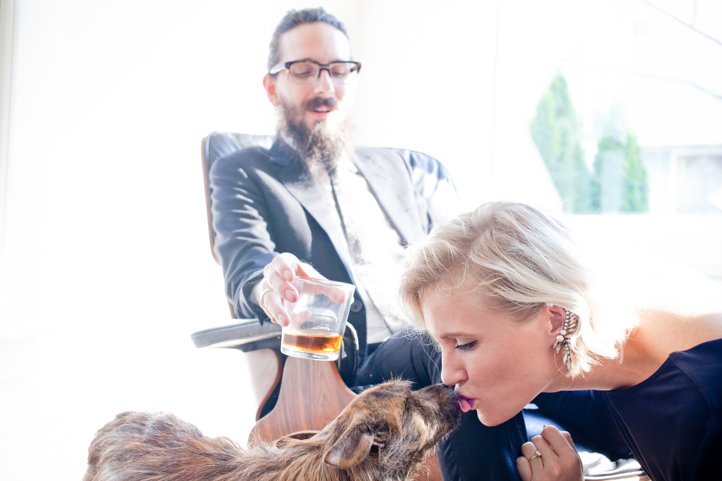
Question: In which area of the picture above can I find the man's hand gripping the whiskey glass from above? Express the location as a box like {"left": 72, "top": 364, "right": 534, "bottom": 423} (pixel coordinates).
{"left": 253, "top": 252, "right": 323, "bottom": 326}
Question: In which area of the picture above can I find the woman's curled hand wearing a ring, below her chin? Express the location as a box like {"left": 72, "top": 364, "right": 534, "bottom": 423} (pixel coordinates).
{"left": 516, "top": 426, "right": 584, "bottom": 481}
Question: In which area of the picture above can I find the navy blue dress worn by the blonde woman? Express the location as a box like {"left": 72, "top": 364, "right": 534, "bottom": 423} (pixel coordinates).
{"left": 594, "top": 339, "right": 722, "bottom": 481}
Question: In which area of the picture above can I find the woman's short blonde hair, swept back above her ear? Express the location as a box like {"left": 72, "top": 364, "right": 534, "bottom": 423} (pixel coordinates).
{"left": 401, "top": 202, "right": 627, "bottom": 377}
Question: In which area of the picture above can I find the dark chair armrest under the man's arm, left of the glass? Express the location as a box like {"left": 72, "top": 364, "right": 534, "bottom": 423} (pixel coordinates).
{"left": 191, "top": 319, "right": 281, "bottom": 352}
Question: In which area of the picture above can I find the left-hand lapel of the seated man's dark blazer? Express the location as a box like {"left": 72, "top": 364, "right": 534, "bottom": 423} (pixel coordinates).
{"left": 270, "top": 141, "right": 353, "bottom": 279}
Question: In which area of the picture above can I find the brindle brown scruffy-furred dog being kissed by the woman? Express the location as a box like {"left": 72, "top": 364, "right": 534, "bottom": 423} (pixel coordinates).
{"left": 84, "top": 381, "right": 460, "bottom": 481}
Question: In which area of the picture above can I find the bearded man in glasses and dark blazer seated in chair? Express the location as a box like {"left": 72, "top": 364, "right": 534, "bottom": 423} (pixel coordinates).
{"left": 209, "top": 8, "right": 526, "bottom": 481}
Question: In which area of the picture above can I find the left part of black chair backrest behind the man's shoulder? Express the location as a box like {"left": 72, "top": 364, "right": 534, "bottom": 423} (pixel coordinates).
{"left": 201, "top": 132, "right": 274, "bottom": 263}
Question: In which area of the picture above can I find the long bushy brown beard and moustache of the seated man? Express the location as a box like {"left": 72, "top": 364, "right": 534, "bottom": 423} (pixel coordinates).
{"left": 278, "top": 97, "right": 352, "bottom": 175}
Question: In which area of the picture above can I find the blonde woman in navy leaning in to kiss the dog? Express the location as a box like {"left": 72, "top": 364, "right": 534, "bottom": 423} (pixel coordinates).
{"left": 401, "top": 202, "right": 722, "bottom": 481}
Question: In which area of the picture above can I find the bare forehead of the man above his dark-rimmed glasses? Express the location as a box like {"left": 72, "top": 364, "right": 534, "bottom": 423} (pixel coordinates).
{"left": 279, "top": 22, "right": 351, "bottom": 62}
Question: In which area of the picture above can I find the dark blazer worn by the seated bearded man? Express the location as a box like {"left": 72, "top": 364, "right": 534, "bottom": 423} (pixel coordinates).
{"left": 209, "top": 140, "right": 455, "bottom": 352}
